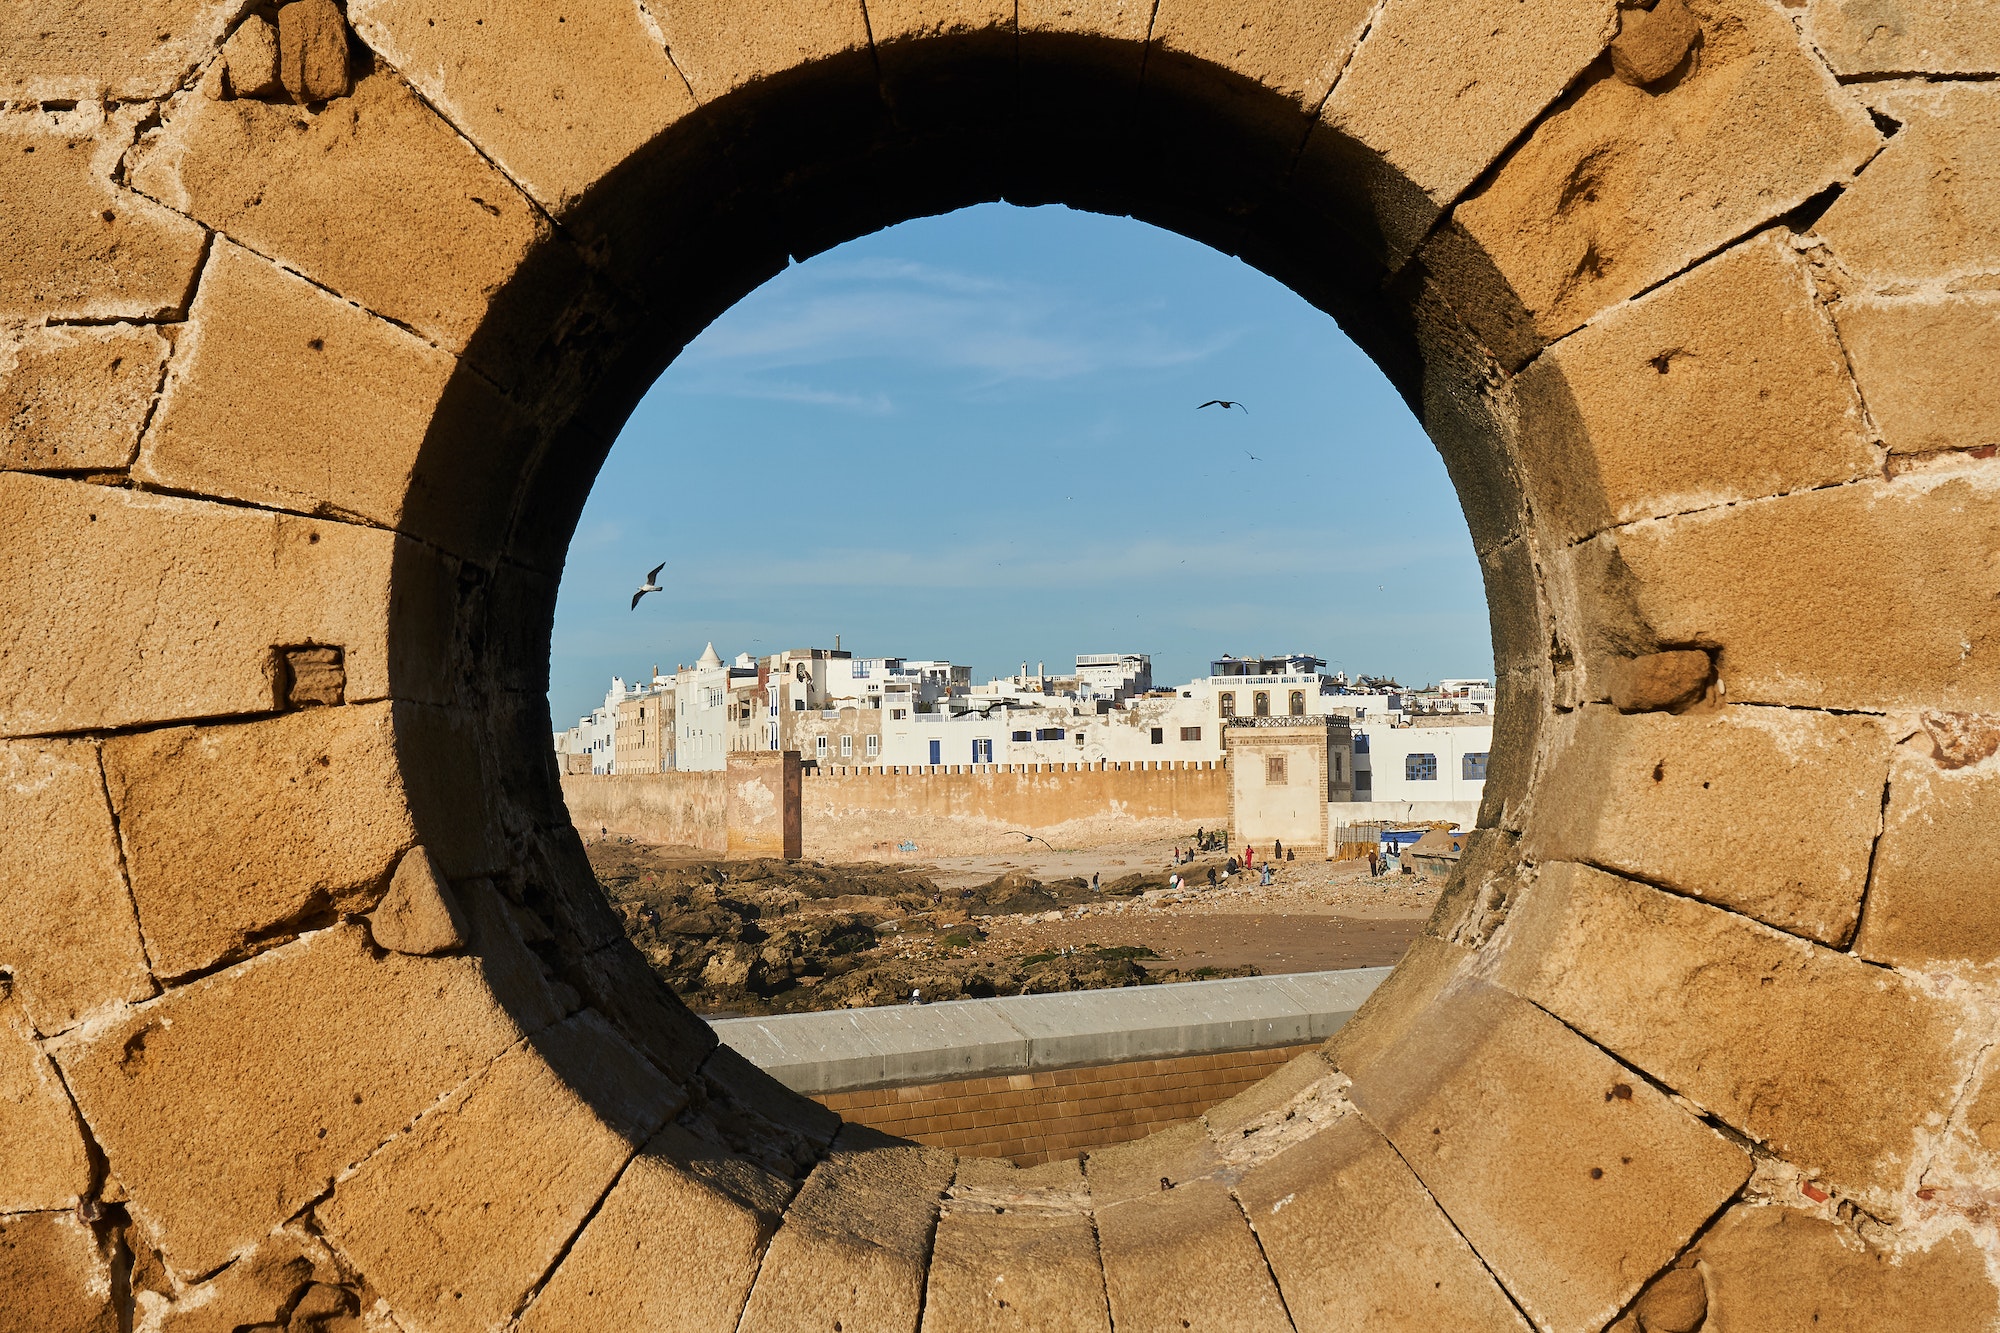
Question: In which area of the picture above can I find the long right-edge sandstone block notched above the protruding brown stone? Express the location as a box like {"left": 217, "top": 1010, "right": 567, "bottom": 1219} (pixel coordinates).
{"left": 1548, "top": 472, "right": 2000, "bottom": 713}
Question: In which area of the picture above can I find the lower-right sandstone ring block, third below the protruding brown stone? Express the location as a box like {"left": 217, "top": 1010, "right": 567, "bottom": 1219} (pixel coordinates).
{"left": 1350, "top": 964, "right": 1750, "bottom": 1333}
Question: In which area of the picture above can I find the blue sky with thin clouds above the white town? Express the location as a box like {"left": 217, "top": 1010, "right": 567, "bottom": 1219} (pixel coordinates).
{"left": 550, "top": 204, "right": 1492, "bottom": 727}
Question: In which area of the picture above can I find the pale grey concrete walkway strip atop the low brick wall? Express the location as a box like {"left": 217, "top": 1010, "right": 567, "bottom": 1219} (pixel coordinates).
{"left": 714, "top": 967, "right": 1390, "bottom": 1093}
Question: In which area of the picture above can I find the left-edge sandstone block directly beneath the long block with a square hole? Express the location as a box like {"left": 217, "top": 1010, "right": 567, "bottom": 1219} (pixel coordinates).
{"left": 0, "top": 741, "right": 154, "bottom": 1033}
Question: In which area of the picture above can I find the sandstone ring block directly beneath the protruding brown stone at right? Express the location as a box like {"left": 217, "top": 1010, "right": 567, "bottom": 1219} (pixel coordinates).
{"left": 1524, "top": 705, "right": 1890, "bottom": 949}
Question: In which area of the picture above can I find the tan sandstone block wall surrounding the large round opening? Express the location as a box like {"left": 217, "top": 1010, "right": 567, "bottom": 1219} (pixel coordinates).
{"left": 0, "top": 0, "right": 2000, "bottom": 1333}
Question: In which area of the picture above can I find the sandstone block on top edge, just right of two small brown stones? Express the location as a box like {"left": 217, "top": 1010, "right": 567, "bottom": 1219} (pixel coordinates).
{"left": 348, "top": 0, "right": 704, "bottom": 214}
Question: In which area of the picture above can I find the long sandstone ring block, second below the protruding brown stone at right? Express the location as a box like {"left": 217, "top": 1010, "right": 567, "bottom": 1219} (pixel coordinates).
{"left": 1504, "top": 865, "right": 1972, "bottom": 1200}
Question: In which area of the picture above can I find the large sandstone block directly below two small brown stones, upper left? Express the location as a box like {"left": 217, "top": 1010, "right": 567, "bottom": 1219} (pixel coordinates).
{"left": 132, "top": 69, "right": 552, "bottom": 352}
